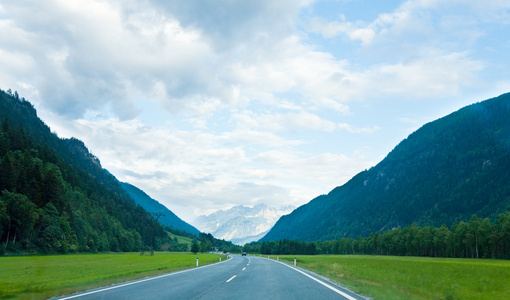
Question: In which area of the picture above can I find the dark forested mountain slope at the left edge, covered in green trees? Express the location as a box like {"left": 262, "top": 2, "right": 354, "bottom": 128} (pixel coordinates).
{"left": 0, "top": 91, "right": 168, "bottom": 253}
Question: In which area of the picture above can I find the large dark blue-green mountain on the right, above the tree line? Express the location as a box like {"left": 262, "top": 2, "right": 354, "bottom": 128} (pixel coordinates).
{"left": 262, "top": 94, "right": 510, "bottom": 241}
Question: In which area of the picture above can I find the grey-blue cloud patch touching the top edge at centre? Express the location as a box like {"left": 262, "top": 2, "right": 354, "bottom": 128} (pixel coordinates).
{"left": 146, "top": 0, "right": 313, "bottom": 48}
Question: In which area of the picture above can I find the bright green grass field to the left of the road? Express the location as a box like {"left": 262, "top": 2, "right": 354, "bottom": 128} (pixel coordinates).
{"left": 0, "top": 252, "right": 219, "bottom": 299}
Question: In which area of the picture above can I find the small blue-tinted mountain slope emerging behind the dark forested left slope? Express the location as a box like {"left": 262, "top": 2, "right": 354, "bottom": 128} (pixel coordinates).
{"left": 120, "top": 182, "right": 200, "bottom": 235}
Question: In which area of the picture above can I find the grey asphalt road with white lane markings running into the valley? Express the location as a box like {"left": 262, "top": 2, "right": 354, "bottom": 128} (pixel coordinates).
{"left": 59, "top": 256, "right": 363, "bottom": 300}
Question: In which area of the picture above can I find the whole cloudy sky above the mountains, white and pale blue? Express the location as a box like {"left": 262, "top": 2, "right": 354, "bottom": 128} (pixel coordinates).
{"left": 0, "top": 0, "right": 510, "bottom": 222}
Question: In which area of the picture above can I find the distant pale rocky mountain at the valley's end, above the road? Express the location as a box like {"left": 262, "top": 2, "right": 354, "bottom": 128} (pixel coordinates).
{"left": 192, "top": 204, "right": 294, "bottom": 245}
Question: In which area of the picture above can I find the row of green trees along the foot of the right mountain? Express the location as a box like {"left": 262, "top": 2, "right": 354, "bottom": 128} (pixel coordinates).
{"left": 244, "top": 212, "right": 510, "bottom": 259}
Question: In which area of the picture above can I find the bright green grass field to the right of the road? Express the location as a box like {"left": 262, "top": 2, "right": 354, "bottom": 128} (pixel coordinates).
{"left": 271, "top": 255, "right": 510, "bottom": 300}
